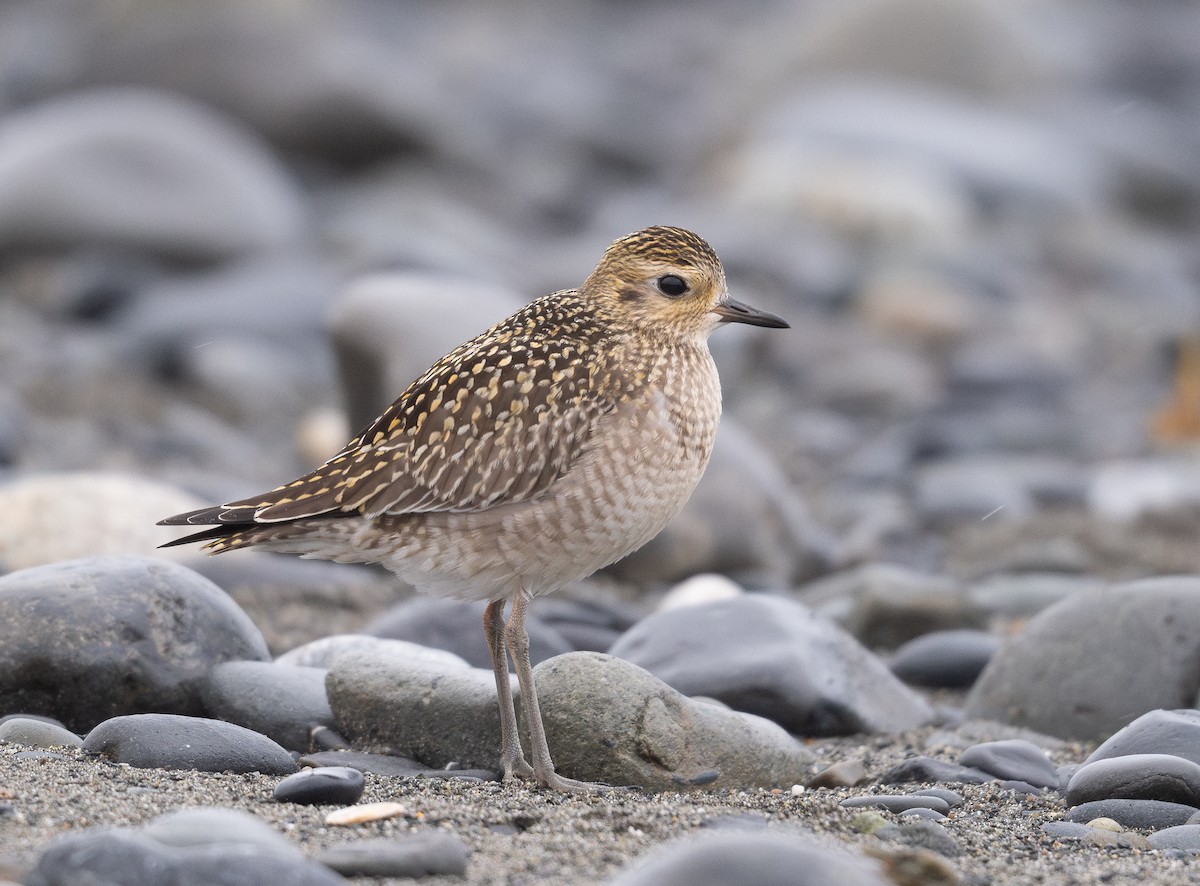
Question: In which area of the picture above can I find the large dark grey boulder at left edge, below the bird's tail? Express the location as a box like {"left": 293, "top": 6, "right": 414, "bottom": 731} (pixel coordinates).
{"left": 0, "top": 557, "right": 268, "bottom": 732}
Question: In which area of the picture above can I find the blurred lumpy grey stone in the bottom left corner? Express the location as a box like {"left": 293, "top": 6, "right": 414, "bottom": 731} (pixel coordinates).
{"left": 25, "top": 828, "right": 346, "bottom": 886}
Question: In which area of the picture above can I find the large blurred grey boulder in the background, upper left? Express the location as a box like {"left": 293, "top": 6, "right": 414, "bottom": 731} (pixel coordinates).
{"left": 0, "top": 88, "right": 305, "bottom": 262}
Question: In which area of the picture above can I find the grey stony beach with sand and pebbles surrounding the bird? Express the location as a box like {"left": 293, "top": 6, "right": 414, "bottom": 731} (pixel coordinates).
{"left": 0, "top": 0, "right": 1200, "bottom": 885}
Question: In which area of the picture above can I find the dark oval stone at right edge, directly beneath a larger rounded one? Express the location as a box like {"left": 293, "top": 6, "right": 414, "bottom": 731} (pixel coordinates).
{"left": 1064, "top": 754, "right": 1200, "bottom": 807}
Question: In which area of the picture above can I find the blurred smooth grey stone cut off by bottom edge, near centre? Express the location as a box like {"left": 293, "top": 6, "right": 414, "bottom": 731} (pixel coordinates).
{"left": 611, "top": 832, "right": 890, "bottom": 886}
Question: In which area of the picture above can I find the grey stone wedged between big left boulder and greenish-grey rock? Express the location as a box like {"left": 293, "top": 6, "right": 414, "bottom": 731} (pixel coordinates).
{"left": 200, "top": 661, "right": 334, "bottom": 752}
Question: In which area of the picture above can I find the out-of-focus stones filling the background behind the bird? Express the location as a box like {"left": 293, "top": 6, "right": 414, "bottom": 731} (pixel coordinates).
{"left": 0, "top": 0, "right": 1200, "bottom": 609}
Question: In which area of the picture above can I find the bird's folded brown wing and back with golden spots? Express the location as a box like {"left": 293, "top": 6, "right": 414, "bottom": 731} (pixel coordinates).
{"left": 170, "top": 290, "right": 614, "bottom": 523}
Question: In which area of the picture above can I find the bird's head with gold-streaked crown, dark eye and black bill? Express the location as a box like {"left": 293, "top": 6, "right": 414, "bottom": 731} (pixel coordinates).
{"left": 582, "top": 225, "right": 787, "bottom": 339}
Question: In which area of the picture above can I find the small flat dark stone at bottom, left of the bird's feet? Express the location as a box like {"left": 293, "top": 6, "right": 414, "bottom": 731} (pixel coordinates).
{"left": 316, "top": 831, "right": 469, "bottom": 878}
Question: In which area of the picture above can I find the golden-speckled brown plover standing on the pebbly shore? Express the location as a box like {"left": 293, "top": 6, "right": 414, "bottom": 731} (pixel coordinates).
{"left": 160, "top": 226, "right": 788, "bottom": 792}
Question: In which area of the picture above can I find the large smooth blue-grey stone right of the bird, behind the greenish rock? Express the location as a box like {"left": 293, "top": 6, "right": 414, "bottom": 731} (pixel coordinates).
{"left": 611, "top": 594, "right": 932, "bottom": 736}
